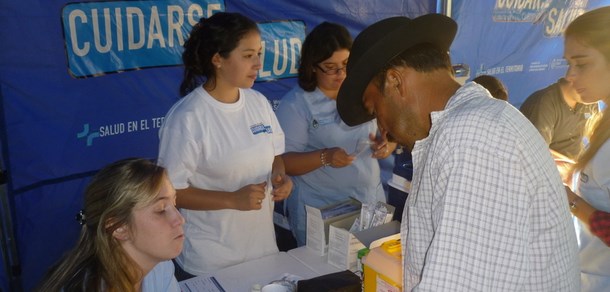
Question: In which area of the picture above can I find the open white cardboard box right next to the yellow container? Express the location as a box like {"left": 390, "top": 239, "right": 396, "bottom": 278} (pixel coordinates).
{"left": 328, "top": 217, "right": 400, "bottom": 272}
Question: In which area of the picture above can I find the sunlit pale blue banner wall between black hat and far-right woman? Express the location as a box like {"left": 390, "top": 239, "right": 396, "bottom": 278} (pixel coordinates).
{"left": 451, "top": 0, "right": 610, "bottom": 107}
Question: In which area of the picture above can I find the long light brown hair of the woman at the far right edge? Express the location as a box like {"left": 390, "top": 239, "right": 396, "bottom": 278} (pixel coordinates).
{"left": 564, "top": 6, "right": 610, "bottom": 170}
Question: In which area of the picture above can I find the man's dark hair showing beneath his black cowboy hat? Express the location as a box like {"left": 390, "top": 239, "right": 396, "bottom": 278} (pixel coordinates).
{"left": 373, "top": 43, "right": 453, "bottom": 88}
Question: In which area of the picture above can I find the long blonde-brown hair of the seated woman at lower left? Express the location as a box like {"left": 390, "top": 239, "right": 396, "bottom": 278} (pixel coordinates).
{"left": 37, "top": 158, "right": 166, "bottom": 291}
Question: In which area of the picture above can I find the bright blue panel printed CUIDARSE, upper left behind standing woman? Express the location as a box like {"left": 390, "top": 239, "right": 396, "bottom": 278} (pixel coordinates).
{"left": 62, "top": 0, "right": 225, "bottom": 77}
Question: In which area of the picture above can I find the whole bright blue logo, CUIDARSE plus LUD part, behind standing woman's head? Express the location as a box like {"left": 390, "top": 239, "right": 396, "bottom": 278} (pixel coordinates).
{"left": 62, "top": 0, "right": 305, "bottom": 81}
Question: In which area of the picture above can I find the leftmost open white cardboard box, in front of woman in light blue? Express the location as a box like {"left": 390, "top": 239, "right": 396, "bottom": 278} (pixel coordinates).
{"left": 305, "top": 199, "right": 362, "bottom": 256}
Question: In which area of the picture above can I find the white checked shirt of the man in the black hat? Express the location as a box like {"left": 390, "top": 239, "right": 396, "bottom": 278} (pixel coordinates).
{"left": 401, "top": 83, "right": 580, "bottom": 291}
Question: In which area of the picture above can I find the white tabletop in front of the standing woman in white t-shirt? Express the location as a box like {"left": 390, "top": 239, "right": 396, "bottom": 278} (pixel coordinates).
{"left": 180, "top": 247, "right": 339, "bottom": 292}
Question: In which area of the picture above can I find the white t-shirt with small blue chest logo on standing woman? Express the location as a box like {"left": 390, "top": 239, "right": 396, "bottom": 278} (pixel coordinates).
{"left": 159, "top": 87, "right": 284, "bottom": 275}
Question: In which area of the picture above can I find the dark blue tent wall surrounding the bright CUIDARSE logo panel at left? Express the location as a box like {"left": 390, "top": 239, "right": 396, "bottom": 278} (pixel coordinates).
{"left": 0, "top": 0, "right": 437, "bottom": 291}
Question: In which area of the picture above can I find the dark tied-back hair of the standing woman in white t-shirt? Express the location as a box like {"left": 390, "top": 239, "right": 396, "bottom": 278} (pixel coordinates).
{"left": 180, "top": 12, "right": 259, "bottom": 96}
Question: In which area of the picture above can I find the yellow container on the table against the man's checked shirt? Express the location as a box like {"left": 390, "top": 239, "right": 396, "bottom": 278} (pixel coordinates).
{"left": 362, "top": 239, "right": 402, "bottom": 292}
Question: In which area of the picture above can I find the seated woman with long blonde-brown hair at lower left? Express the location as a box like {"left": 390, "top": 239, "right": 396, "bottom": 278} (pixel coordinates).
{"left": 38, "top": 159, "right": 184, "bottom": 291}
